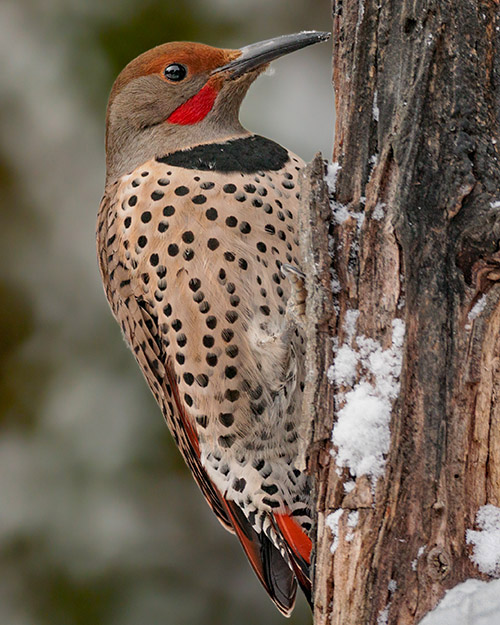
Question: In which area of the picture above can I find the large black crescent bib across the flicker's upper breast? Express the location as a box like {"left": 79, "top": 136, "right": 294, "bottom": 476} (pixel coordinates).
{"left": 156, "top": 135, "right": 290, "bottom": 174}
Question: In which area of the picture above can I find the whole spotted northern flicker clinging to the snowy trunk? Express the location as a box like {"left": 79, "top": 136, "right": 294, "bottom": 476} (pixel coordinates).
{"left": 97, "top": 32, "right": 329, "bottom": 615}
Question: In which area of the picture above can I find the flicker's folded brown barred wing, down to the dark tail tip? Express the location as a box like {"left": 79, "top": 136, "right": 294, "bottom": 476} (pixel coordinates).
{"left": 97, "top": 188, "right": 297, "bottom": 616}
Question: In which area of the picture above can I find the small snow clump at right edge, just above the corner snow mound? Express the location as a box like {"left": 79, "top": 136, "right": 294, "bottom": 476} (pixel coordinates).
{"left": 466, "top": 504, "right": 500, "bottom": 576}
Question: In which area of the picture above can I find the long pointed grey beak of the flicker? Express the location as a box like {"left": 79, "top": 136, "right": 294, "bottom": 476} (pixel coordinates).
{"left": 212, "top": 30, "right": 330, "bottom": 78}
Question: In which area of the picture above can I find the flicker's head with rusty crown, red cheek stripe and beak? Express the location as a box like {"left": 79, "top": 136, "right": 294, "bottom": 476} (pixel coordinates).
{"left": 106, "top": 31, "right": 329, "bottom": 181}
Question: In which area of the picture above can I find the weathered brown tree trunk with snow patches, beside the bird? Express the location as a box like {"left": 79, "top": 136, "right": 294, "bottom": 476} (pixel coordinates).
{"left": 301, "top": 0, "right": 500, "bottom": 625}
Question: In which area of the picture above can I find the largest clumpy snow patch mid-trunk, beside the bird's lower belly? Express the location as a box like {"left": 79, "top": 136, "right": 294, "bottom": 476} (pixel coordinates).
{"left": 331, "top": 320, "right": 405, "bottom": 484}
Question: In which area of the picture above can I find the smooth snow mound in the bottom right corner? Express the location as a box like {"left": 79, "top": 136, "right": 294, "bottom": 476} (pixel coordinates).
{"left": 419, "top": 579, "right": 500, "bottom": 625}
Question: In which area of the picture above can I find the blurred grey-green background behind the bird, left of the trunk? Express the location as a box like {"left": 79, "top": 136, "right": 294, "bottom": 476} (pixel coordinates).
{"left": 0, "top": 0, "right": 333, "bottom": 625}
